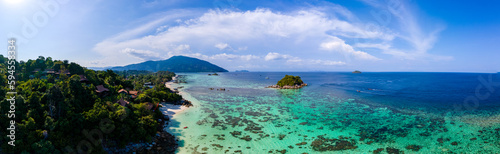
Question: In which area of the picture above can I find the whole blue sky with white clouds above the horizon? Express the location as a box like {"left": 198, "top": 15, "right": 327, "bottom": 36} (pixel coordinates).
{"left": 0, "top": 0, "right": 500, "bottom": 72}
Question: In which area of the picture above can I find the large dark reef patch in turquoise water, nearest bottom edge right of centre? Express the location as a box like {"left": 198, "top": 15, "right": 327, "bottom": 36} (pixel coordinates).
{"left": 311, "top": 135, "right": 358, "bottom": 151}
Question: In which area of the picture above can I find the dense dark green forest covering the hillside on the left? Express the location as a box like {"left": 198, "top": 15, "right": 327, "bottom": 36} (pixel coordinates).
{"left": 0, "top": 55, "right": 182, "bottom": 153}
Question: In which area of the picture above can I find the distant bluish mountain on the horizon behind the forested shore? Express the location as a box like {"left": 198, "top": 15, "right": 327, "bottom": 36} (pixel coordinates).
{"left": 111, "top": 56, "right": 228, "bottom": 72}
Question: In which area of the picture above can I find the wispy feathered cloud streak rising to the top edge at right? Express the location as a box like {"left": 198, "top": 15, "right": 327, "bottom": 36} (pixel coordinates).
{"left": 356, "top": 0, "right": 453, "bottom": 60}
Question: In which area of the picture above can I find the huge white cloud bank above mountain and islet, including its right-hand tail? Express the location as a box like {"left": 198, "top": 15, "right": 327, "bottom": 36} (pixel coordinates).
{"left": 94, "top": 5, "right": 454, "bottom": 70}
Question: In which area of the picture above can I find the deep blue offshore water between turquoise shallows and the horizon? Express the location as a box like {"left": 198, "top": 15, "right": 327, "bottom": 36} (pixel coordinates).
{"left": 224, "top": 72, "right": 500, "bottom": 112}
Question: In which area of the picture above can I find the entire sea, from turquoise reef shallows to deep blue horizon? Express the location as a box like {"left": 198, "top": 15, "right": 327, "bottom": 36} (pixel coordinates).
{"left": 169, "top": 72, "right": 500, "bottom": 154}
